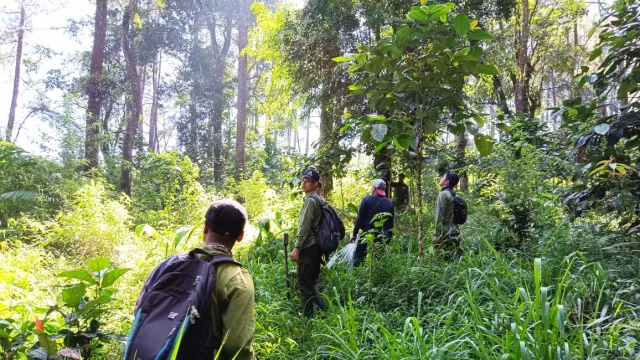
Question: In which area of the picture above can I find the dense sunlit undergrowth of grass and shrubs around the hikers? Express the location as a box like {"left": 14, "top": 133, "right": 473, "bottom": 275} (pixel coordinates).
{"left": 0, "top": 139, "right": 640, "bottom": 359}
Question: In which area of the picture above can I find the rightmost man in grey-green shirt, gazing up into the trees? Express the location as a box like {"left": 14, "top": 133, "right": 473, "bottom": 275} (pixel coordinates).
{"left": 433, "top": 172, "right": 466, "bottom": 258}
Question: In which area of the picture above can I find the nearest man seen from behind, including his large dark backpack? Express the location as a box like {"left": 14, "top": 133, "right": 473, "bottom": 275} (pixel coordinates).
{"left": 124, "top": 200, "right": 255, "bottom": 360}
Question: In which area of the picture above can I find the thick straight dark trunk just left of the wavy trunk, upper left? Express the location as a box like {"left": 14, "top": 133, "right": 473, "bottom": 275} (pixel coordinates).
{"left": 84, "top": 0, "right": 107, "bottom": 170}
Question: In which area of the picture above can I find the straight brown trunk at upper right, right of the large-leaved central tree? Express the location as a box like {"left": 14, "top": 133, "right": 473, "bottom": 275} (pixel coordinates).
{"left": 513, "top": 0, "right": 530, "bottom": 115}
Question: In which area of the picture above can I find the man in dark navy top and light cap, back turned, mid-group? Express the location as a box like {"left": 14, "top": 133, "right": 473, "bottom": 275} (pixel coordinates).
{"left": 351, "top": 179, "right": 395, "bottom": 266}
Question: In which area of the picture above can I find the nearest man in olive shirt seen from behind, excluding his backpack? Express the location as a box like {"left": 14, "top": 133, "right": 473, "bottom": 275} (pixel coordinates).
{"left": 136, "top": 200, "right": 255, "bottom": 360}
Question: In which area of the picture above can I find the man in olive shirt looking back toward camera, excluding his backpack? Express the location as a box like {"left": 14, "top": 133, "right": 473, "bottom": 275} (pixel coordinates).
{"left": 291, "top": 169, "right": 326, "bottom": 317}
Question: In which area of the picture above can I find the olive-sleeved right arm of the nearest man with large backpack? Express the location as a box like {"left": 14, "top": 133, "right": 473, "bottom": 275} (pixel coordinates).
{"left": 220, "top": 269, "right": 255, "bottom": 360}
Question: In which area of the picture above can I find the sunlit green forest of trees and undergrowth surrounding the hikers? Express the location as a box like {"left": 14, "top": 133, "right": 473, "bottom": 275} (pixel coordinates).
{"left": 0, "top": 0, "right": 640, "bottom": 360}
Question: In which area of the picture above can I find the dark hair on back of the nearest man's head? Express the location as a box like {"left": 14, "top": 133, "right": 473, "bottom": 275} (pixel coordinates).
{"left": 204, "top": 200, "right": 247, "bottom": 245}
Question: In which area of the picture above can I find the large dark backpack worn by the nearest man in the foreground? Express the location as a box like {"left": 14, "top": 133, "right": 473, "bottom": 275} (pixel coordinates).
{"left": 124, "top": 249, "right": 240, "bottom": 360}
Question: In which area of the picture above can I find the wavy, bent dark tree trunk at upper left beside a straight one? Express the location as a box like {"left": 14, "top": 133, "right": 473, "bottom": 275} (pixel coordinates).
{"left": 120, "top": 0, "right": 142, "bottom": 195}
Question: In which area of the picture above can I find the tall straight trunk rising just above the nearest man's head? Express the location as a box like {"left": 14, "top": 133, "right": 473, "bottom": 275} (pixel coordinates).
{"left": 235, "top": 0, "right": 249, "bottom": 180}
